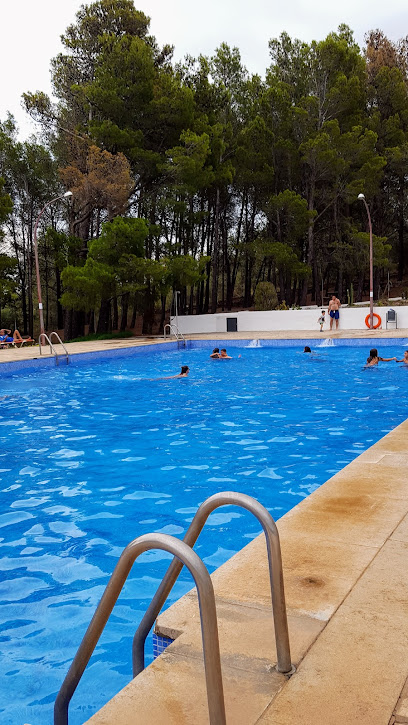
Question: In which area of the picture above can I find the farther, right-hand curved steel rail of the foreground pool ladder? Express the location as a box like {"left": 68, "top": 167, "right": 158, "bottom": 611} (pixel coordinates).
{"left": 132, "top": 491, "right": 295, "bottom": 677}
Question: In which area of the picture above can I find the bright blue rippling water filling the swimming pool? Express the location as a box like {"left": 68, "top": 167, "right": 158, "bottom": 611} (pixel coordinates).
{"left": 0, "top": 341, "right": 408, "bottom": 725}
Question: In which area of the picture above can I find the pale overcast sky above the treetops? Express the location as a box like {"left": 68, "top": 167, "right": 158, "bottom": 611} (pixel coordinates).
{"left": 0, "top": 0, "right": 408, "bottom": 138}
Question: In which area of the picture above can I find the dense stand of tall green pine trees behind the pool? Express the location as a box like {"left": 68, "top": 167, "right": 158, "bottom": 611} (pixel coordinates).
{"left": 6, "top": 12, "right": 408, "bottom": 334}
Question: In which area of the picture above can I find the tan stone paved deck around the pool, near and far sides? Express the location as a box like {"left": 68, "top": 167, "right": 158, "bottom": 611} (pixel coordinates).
{"left": 5, "top": 330, "right": 408, "bottom": 725}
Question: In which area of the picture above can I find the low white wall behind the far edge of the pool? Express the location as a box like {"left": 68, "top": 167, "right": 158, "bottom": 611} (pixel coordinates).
{"left": 171, "top": 305, "right": 408, "bottom": 335}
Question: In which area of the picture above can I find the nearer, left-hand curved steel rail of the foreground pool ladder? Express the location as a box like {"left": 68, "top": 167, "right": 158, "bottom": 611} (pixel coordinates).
{"left": 54, "top": 534, "right": 226, "bottom": 725}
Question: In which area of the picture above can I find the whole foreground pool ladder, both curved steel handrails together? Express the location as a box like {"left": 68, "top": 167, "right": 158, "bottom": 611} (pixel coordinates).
{"left": 54, "top": 491, "right": 295, "bottom": 725}
